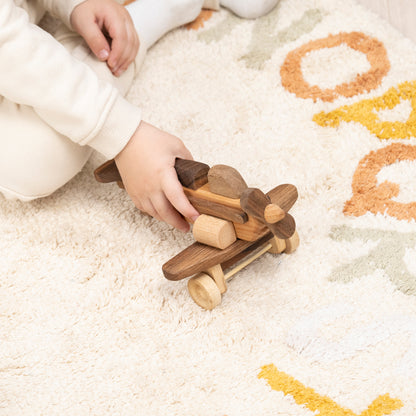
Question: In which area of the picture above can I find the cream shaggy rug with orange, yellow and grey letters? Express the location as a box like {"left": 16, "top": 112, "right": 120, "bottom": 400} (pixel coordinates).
{"left": 0, "top": 0, "right": 416, "bottom": 416}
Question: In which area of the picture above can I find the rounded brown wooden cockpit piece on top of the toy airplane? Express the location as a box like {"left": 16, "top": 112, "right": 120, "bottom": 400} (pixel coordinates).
{"left": 208, "top": 165, "right": 247, "bottom": 199}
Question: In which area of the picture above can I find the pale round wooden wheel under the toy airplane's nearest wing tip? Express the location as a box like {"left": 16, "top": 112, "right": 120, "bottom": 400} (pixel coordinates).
{"left": 188, "top": 273, "right": 221, "bottom": 310}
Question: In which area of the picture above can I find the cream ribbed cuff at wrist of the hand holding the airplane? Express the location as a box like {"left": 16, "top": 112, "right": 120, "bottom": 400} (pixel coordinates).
{"left": 85, "top": 96, "right": 141, "bottom": 159}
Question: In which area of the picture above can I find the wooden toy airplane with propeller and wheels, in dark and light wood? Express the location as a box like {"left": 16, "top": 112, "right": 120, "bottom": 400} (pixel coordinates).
{"left": 94, "top": 159, "right": 299, "bottom": 310}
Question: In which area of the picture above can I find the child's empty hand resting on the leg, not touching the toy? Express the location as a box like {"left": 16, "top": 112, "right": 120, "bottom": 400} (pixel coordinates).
{"left": 71, "top": 0, "right": 140, "bottom": 76}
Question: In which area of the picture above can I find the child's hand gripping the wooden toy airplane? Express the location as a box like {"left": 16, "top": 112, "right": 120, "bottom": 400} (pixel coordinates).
{"left": 115, "top": 121, "right": 199, "bottom": 232}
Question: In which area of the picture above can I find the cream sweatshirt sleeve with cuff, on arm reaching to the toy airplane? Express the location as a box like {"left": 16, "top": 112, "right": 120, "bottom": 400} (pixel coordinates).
{"left": 0, "top": 0, "right": 141, "bottom": 158}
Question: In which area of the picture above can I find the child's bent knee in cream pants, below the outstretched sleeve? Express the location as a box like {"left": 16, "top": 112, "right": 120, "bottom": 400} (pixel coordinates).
{"left": 0, "top": 100, "right": 92, "bottom": 201}
